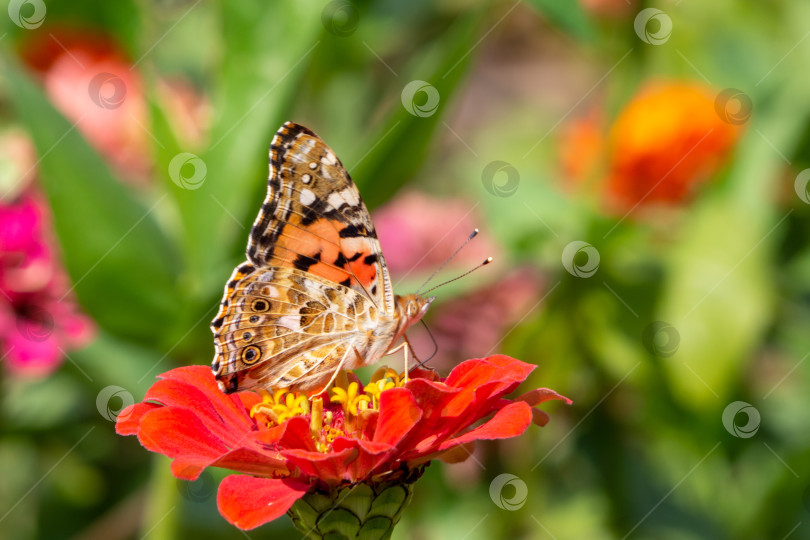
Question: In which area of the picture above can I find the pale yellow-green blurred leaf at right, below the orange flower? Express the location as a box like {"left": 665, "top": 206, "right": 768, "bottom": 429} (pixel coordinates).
{"left": 660, "top": 88, "right": 805, "bottom": 404}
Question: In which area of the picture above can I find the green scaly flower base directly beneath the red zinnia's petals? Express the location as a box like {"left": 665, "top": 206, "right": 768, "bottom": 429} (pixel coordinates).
{"left": 287, "top": 468, "right": 424, "bottom": 540}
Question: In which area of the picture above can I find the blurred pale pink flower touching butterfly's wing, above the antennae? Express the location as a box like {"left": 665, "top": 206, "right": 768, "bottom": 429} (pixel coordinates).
{"left": 374, "top": 192, "right": 496, "bottom": 277}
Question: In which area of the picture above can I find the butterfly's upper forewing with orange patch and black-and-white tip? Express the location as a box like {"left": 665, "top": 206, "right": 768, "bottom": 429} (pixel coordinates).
{"left": 247, "top": 122, "right": 394, "bottom": 314}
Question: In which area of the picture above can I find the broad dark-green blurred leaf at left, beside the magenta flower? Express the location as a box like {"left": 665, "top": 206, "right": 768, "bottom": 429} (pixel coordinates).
{"left": 3, "top": 51, "right": 177, "bottom": 339}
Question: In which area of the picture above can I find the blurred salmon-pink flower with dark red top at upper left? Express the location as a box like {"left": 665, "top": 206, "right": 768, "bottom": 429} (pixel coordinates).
{"left": 23, "top": 28, "right": 151, "bottom": 184}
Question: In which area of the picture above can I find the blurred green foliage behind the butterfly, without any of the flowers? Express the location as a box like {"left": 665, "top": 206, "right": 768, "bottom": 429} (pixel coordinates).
{"left": 0, "top": 0, "right": 810, "bottom": 540}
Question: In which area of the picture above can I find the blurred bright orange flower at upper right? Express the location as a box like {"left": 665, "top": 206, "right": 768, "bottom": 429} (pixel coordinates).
{"left": 561, "top": 81, "right": 742, "bottom": 213}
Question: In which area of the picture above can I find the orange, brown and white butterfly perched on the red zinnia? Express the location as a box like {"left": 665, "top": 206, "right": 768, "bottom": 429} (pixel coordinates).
{"left": 211, "top": 122, "right": 433, "bottom": 395}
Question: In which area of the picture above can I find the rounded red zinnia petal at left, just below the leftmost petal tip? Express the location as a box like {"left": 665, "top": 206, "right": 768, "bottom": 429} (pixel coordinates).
{"left": 138, "top": 407, "right": 228, "bottom": 459}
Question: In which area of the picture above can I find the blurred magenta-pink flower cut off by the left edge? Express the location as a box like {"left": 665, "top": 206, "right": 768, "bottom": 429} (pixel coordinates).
{"left": 0, "top": 131, "right": 93, "bottom": 376}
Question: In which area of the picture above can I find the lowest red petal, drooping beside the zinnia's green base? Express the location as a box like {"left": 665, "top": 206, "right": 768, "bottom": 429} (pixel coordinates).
{"left": 217, "top": 475, "right": 309, "bottom": 530}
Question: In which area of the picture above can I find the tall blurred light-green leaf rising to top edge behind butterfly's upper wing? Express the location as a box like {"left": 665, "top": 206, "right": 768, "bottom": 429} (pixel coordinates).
{"left": 172, "top": 0, "right": 321, "bottom": 301}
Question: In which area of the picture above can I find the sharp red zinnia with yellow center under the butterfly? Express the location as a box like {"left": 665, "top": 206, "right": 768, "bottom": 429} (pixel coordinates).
{"left": 116, "top": 356, "right": 570, "bottom": 532}
